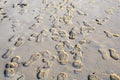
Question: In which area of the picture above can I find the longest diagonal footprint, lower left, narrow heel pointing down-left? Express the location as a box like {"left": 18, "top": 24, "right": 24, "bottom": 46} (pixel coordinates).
{"left": 23, "top": 53, "right": 41, "bottom": 67}
